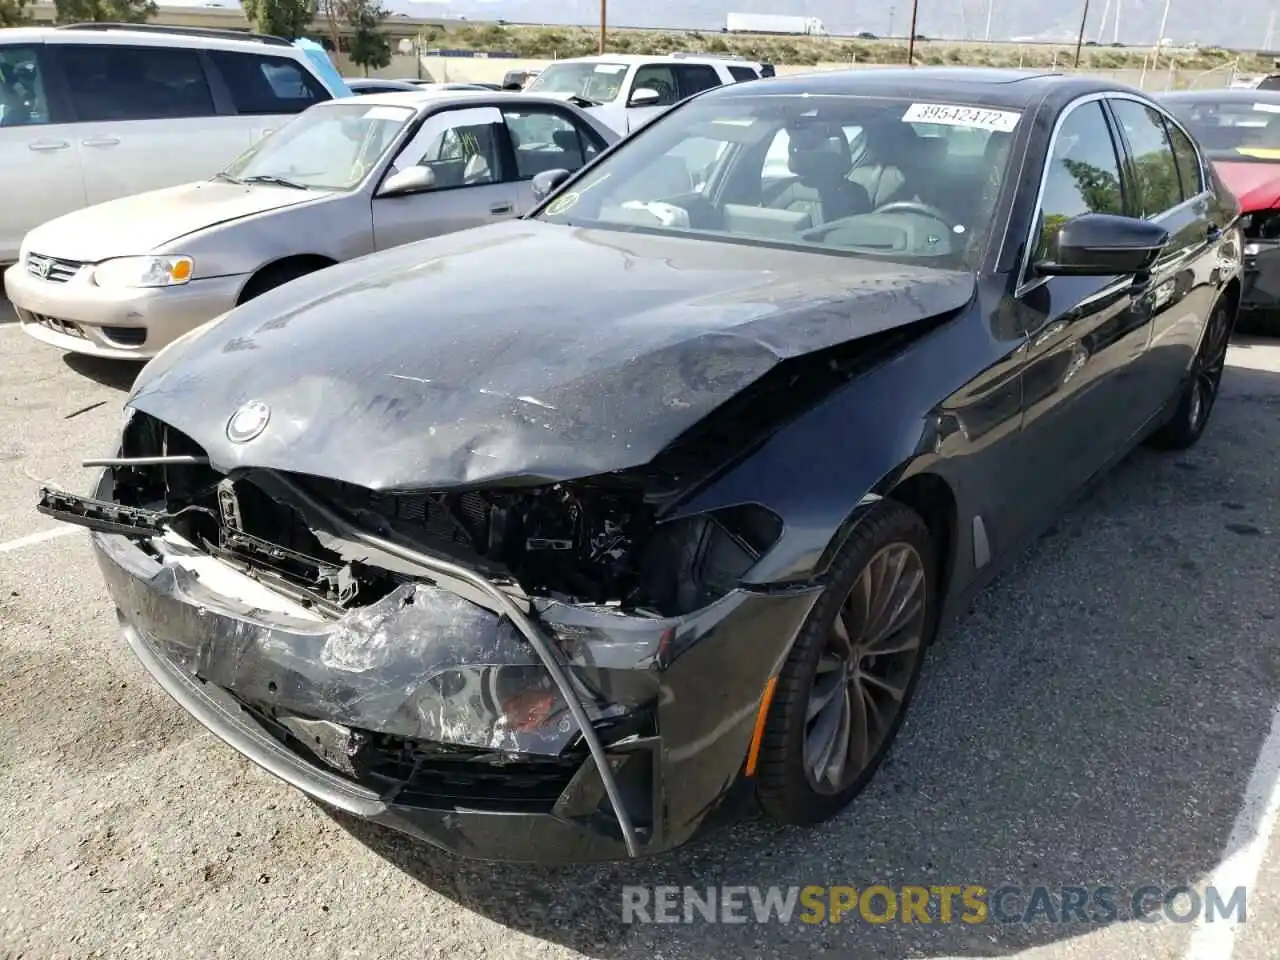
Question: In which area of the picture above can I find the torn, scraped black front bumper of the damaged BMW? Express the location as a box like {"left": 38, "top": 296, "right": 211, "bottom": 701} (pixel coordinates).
{"left": 80, "top": 473, "right": 817, "bottom": 860}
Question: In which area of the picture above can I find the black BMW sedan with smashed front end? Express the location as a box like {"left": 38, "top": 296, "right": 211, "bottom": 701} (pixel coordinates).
{"left": 41, "top": 69, "right": 1240, "bottom": 860}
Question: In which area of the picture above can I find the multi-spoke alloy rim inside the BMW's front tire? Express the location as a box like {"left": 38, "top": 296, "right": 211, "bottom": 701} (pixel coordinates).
{"left": 804, "top": 543, "right": 928, "bottom": 795}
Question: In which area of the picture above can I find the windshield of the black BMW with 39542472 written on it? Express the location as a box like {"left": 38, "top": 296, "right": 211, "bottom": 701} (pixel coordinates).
{"left": 538, "top": 96, "right": 1020, "bottom": 268}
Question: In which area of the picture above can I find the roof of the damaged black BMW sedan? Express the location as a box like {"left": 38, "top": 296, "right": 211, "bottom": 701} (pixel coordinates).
{"left": 709, "top": 67, "right": 1140, "bottom": 109}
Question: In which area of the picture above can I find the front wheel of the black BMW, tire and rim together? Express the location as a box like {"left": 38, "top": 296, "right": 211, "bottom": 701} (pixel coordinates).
{"left": 756, "top": 500, "right": 938, "bottom": 824}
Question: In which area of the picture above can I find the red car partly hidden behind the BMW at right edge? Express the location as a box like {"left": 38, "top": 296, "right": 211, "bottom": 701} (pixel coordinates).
{"left": 1158, "top": 90, "right": 1280, "bottom": 332}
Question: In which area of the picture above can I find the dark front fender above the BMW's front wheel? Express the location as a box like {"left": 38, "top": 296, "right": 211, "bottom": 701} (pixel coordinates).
{"left": 678, "top": 310, "right": 1020, "bottom": 586}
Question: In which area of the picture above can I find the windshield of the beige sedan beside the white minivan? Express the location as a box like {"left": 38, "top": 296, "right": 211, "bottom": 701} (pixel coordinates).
{"left": 220, "top": 100, "right": 417, "bottom": 191}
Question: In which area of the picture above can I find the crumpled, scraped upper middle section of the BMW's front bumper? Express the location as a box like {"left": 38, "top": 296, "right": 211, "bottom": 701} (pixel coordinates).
{"left": 126, "top": 564, "right": 600, "bottom": 754}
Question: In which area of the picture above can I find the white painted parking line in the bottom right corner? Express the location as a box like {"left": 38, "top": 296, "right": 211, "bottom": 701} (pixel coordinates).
{"left": 1187, "top": 707, "right": 1280, "bottom": 960}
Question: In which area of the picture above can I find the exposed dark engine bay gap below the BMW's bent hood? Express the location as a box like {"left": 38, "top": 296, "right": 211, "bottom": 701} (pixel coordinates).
{"left": 85, "top": 413, "right": 781, "bottom": 616}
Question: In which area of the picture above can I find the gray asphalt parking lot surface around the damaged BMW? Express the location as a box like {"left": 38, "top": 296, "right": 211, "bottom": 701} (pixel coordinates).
{"left": 0, "top": 305, "right": 1280, "bottom": 960}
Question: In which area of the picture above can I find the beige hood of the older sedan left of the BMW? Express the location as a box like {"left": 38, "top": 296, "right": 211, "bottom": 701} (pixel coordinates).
{"left": 23, "top": 180, "right": 330, "bottom": 264}
